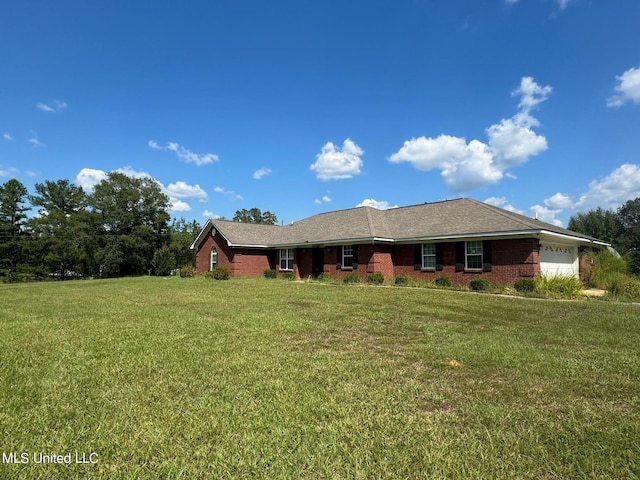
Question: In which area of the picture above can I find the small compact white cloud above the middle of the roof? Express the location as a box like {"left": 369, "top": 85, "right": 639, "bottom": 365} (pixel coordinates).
{"left": 310, "top": 138, "right": 364, "bottom": 180}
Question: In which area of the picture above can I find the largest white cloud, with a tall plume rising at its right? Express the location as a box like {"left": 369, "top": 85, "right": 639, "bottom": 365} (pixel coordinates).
{"left": 389, "top": 77, "right": 551, "bottom": 193}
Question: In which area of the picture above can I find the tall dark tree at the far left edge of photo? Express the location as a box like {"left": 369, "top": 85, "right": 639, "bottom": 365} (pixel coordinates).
{"left": 0, "top": 178, "right": 31, "bottom": 281}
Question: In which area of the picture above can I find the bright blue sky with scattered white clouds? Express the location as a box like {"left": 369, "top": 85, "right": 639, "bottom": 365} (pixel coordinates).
{"left": 0, "top": 0, "right": 640, "bottom": 226}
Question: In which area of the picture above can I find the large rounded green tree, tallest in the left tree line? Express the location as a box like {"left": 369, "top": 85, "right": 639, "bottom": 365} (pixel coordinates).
{"left": 89, "top": 172, "right": 170, "bottom": 277}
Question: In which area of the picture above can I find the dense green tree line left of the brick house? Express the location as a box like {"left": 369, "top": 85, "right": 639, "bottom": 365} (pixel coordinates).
{"left": 0, "top": 172, "right": 200, "bottom": 281}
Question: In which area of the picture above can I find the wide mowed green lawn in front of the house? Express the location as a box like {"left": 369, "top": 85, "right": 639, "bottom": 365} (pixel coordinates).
{"left": 0, "top": 277, "right": 640, "bottom": 479}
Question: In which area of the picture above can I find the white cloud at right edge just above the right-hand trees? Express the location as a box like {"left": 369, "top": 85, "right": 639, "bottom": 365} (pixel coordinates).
{"left": 574, "top": 163, "right": 640, "bottom": 211}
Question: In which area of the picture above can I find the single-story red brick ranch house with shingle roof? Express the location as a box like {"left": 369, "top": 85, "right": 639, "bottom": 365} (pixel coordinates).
{"left": 191, "top": 198, "right": 608, "bottom": 285}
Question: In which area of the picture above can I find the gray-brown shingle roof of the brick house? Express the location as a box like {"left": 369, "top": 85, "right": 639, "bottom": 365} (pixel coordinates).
{"left": 194, "top": 198, "right": 604, "bottom": 247}
